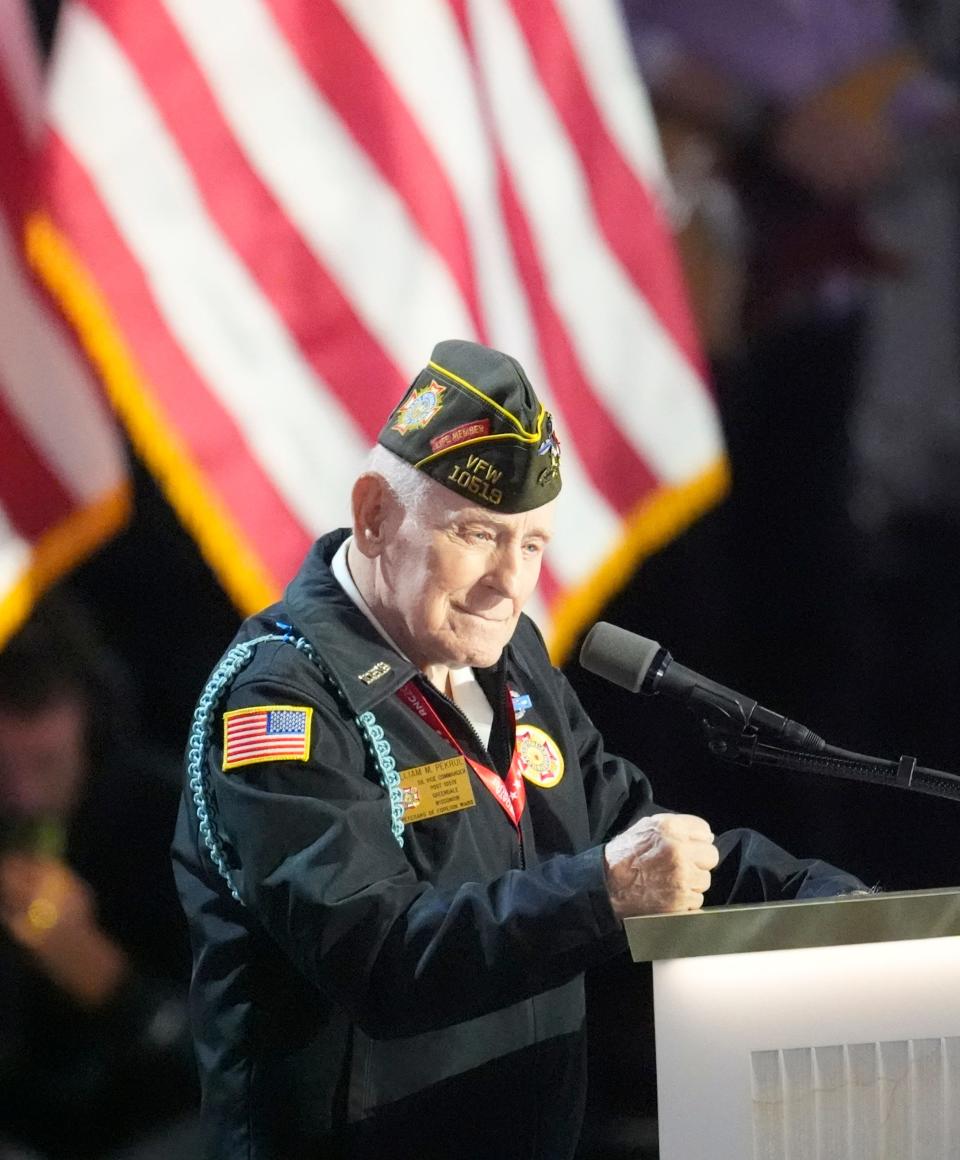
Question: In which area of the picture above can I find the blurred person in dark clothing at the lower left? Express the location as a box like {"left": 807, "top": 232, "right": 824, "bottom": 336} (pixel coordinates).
{"left": 0, "top": 597, "right": 196, "bottom": 1158}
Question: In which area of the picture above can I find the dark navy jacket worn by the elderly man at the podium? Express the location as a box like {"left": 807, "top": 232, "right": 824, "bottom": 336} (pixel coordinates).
{"left": 174, "top": 532, "right": 859, "bottom": 1160}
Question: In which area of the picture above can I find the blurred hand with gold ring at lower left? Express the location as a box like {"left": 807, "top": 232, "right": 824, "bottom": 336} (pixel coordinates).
{"left": 0, "top": 854, "right": 126, "bottom": 1007}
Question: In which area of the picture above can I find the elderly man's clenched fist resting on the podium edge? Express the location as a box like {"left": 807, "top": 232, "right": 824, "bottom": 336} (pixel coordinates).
{"left": 604, "top": 813, "right": 720, "bottom": 919}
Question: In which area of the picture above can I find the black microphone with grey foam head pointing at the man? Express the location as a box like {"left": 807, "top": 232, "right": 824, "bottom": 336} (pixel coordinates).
{"left": 580, "top": 621, "right": 827, "bottom": 753}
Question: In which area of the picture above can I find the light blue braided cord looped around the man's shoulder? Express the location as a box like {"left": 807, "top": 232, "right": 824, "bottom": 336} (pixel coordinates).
{"left": 187, "top": 633, "right": 403, "bottom": 902}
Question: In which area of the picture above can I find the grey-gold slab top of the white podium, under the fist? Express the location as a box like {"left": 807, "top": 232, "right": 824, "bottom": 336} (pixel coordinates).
{"left": 624, "top": 887, "right": 960, "bottom": 963}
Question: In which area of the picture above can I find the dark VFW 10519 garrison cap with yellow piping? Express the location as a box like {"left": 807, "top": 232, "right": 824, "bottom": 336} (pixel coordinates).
{"left": 379, "top": 339, "right": 560, "bottom": 513}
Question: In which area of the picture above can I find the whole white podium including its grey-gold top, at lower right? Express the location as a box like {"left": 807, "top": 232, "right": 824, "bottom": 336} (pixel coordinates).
{"left": 626, "top": 890, "right": 960, "bottom": 1160}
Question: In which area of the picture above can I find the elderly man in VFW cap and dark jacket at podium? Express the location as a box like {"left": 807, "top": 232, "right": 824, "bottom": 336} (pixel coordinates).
{"left": 174, "top": 341, "right": 859, "bottom": 1160}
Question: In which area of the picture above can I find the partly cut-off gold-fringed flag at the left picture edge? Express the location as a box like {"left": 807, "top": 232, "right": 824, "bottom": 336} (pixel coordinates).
{"left": 0, "top": 0, "right": 129, "bottom": 647}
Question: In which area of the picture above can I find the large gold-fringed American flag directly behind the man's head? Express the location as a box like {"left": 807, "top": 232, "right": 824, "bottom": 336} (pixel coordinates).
{"left": 30, "top": 0, "right": 726, "bottom": 657}
